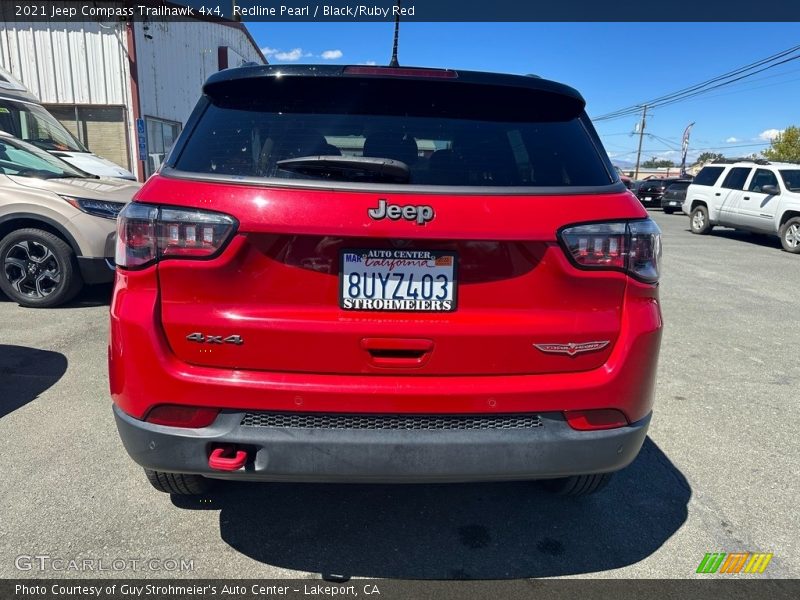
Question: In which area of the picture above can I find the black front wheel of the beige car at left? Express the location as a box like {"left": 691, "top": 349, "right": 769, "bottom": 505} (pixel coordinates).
{"left": 0, "top": 229, "right": 83, "bottom": 308}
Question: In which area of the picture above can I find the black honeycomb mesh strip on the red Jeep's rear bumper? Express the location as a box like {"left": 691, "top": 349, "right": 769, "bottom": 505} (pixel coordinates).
{"left": 242, "top": 412, "right": 543, "bottom": 431}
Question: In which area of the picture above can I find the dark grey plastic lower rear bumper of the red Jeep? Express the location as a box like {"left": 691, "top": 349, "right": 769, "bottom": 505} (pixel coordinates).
{"left": 114, "top": 406, "right": 651, "bottom": 483}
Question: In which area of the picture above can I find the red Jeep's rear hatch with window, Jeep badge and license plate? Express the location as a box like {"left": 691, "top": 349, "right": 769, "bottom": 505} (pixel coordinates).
{"left": 138, "top": 68, "right": 646, "bottom": 375}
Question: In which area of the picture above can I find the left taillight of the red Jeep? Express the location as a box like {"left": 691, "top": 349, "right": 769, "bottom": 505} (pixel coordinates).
{"left": 115, "top": 202, "right": 236, "bottom": 269}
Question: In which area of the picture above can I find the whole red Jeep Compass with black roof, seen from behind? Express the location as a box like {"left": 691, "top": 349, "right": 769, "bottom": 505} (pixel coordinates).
{"left": 109, "top": 66, "right": 662, "bottom": 494}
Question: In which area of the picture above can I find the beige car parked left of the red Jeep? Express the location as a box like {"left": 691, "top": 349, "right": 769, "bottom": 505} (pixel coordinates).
{"left": 0, "top": 133, "right": 140, "bottom": 308}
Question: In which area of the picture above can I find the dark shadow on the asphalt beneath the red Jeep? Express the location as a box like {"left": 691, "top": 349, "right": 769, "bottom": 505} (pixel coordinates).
{"left": 172, "top": 437, "right": 691, "bottom": 579}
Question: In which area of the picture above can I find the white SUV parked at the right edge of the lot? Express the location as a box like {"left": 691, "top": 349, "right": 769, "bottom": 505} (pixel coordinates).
{"left": 682, "top": 160, "right": 800, "bottom": 254}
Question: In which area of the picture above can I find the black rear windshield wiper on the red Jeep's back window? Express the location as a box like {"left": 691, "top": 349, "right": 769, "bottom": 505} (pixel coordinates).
{"left": 277, "top": 155, "right": 411, "bottom": 183}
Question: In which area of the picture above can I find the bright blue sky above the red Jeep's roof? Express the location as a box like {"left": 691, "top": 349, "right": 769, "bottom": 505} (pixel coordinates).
{"left": 247, "top": 22, "right": 800, "bottom": 163}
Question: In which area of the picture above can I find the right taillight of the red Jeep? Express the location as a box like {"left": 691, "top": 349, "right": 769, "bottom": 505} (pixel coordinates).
{"left": 560, "top": 219, "right": 661, "bottom": 283}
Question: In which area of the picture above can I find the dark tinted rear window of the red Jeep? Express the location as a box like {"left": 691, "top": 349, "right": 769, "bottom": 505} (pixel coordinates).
{"left": 173, "top": 78, "right": 616, "bottom": 187}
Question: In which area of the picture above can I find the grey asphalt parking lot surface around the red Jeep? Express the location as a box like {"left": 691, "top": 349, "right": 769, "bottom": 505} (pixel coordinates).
{"left": 0, "top": 210, "right": 800, "bottom": 579}
